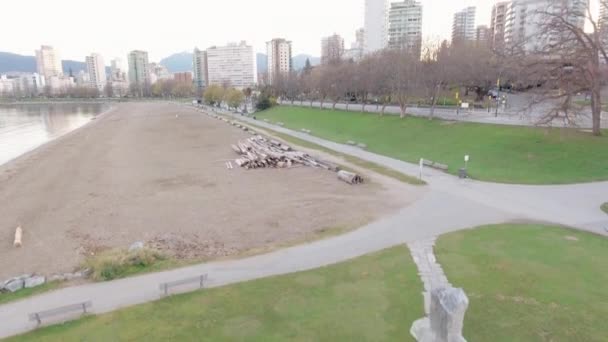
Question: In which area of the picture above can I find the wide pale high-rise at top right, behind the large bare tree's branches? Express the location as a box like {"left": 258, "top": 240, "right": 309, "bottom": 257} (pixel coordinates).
{"left": 505, "top": 0, "right": 589, "bottom": 53}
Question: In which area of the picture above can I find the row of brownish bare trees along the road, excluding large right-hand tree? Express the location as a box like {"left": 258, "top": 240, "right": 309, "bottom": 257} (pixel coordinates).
{"left": 272, "top": 42, "right": 504, "bottom": 117}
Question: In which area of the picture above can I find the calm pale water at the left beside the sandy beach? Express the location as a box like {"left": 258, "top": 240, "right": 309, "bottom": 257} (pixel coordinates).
{"left": 0, "top": 103, "right": 109, "bottom": 165}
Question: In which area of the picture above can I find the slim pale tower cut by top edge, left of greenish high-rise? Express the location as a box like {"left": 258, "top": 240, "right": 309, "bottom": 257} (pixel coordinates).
{"left": 363, "top": 0, "right": 388, "bottom": 54}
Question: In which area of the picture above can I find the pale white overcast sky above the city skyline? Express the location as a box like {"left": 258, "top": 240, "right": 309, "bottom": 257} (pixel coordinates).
{"left": 0, "top": 0, "right": 597, "bottom": 64}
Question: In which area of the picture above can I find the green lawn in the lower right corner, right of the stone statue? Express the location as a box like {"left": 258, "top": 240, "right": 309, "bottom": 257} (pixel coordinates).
{"left": 436, "top": 225, "right": 608, "bottom": 342}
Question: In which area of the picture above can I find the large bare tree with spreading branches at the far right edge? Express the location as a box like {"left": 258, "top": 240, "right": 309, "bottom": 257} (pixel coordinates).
{"left": 522, "top": 0, "right": 608, "bottom": 136}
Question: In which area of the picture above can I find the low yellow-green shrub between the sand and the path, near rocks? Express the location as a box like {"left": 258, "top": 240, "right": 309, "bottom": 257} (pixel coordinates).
{"left": 84, "top": 248, "right": 166, "bottom": 281}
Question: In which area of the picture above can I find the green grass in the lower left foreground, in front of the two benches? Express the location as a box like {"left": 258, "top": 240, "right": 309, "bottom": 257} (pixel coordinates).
{"left": 8, "top": 246, "right": 424, "bottom": 341}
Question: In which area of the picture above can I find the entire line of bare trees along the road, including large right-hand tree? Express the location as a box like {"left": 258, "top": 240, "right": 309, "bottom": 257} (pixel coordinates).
{"left": 269, "top": 0, "right": 608, "bottom": 135}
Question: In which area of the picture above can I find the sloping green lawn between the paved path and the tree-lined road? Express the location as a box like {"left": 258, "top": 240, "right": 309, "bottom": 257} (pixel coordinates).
{"left": 256, "top": 106, "right": 608, "bottom": 184}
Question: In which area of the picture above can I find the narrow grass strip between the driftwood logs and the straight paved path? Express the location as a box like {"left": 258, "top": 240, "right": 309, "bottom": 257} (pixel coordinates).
{"left": 235, "top": 122, "right": 427, "bottom": 185}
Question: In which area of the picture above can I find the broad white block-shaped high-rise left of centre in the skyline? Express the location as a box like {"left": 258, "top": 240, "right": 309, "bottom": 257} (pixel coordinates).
{"left": 207, "top": 41, "right": 257, "bottom": 89}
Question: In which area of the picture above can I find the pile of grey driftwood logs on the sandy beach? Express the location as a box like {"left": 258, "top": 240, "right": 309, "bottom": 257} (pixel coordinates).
{"left": 232, "top": 135, "right": 363, "bottom": 184}
